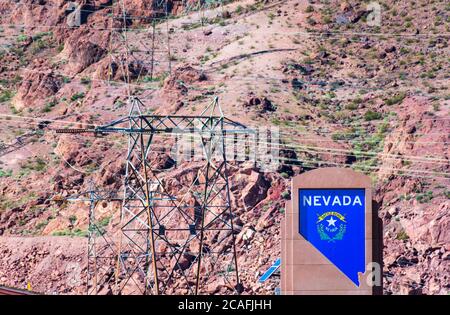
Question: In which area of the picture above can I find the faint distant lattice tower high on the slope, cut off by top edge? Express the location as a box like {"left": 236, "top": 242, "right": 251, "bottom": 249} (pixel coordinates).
{"left": 107, "top": 0, "right": 172, "bottom": 87}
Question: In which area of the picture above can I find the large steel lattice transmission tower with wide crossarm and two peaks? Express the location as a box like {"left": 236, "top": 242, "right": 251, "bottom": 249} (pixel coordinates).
{"left": 58, "top": 98, "right": 250, "bottom": 294}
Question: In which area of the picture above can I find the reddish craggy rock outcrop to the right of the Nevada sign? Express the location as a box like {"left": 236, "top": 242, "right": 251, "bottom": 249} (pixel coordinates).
{"left": 375, "top": 98, "right": 450, "bottom": 294}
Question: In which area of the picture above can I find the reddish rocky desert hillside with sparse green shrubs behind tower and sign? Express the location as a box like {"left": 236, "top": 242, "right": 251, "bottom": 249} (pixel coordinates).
{"left": 0, "top": 0, "right": 450, "bottom": 294}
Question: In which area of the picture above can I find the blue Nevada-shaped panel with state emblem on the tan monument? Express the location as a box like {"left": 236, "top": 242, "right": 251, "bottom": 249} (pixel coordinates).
{"left": 299, "top": 189, "right": 366, "bottom": 287}
